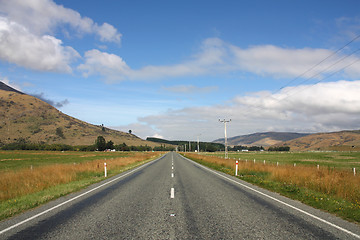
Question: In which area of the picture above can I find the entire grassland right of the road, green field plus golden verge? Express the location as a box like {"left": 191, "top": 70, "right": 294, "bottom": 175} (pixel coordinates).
{"left": 186, "top": 152, "right": 360, "bottom": 223}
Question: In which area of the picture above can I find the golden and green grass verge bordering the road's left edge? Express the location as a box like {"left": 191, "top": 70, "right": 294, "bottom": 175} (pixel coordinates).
{"left": 0, "top": 153, "right": 159, "bottom": 220}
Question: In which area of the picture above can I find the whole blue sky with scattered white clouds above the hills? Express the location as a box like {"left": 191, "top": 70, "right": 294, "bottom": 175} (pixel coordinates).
{"left": 0, "top": 0, "right": 360, "bottom": 141}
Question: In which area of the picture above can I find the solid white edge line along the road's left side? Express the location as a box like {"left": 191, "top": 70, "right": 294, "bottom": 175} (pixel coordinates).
{"left": 0, "top": 157, "right": 161, "bottom": 235}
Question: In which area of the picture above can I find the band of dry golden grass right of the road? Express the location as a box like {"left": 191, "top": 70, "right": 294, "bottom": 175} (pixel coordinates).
{"left": 186, "top": 154, "right": 360, "bottom": 203}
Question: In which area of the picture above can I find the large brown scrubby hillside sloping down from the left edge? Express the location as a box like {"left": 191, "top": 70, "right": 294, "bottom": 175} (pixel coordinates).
{"left": 0, "top": 86, "right": 159, "bottom": 146}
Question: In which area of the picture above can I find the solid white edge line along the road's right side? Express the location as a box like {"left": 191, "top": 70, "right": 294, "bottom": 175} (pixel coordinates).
{"left": 182, "top": 156, "right": 360, "bottom": 239}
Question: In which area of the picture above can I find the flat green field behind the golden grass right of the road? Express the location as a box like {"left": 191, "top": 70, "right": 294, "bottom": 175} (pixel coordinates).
{"left": 206, "top": 151, "right": 360, "bottom": 171}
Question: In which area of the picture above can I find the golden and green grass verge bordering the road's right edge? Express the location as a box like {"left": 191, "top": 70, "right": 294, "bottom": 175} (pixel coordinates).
{"left": 186, "top": 153, "right": 360, "bottom": 223}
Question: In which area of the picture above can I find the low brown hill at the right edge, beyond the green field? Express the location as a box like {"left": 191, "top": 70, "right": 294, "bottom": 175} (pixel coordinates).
{"left": 281, "top": 130, "right": 360, "bottom": 151}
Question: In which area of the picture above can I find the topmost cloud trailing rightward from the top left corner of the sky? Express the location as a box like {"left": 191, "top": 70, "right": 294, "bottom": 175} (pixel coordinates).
{"left": 0, "top": 0, "right": 121, "bottom": 43}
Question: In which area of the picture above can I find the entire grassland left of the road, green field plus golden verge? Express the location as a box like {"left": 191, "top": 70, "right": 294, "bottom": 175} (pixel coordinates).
{"left": 0, "top": 151, "right": 161, "bottom": 220}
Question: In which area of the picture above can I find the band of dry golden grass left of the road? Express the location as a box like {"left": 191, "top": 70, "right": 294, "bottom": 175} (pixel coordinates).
{"left": 0, "top": 152, "right": 159, "bottom": 202}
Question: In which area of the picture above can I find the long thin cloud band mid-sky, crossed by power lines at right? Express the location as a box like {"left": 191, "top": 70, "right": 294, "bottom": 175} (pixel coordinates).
{"left": 79, "top": 38, "right": 360, "bottom": 81}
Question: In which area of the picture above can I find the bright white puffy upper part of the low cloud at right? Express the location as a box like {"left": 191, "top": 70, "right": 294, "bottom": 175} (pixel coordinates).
{"left": 234, "top": 80, "right": 360, "bottom": 116}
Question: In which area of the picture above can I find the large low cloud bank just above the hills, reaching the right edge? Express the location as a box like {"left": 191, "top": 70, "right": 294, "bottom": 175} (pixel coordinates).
{"left": 120, "top": 80, "right": 360, "bottom": 141}
